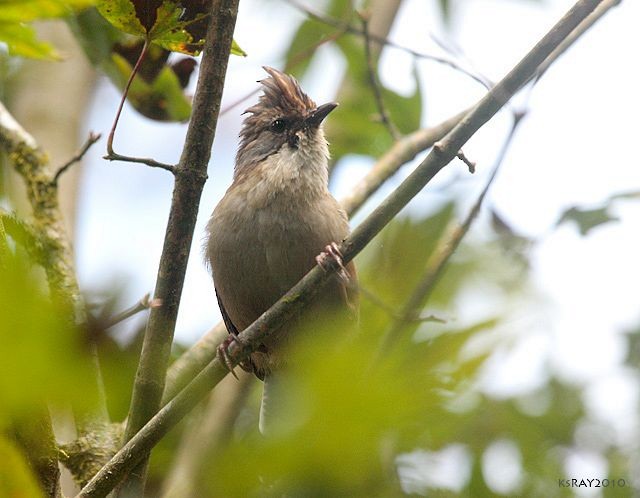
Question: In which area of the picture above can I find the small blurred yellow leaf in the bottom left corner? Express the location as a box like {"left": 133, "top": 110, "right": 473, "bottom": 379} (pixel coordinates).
{"left": 0, "top": 433, "right": 43, "bottom": 498}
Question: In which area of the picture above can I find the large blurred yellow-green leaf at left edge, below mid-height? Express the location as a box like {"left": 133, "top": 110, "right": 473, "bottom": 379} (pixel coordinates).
{"left": 0, "top": 253, "right": 96, "bottom": 419}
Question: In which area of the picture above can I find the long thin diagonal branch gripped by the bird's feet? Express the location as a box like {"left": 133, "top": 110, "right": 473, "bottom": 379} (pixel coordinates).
{"left": 78, "top": 0, "right": 601, "bottom": 498}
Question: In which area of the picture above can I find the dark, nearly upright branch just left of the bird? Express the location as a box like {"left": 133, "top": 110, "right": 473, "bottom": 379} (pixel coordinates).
{"left": 117, "top": 0, "right": 238, "bottom": 496}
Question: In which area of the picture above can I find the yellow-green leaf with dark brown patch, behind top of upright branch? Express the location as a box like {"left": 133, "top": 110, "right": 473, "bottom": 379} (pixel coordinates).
{"left": 97, "top": 0, "right": 246, "bottom": 55}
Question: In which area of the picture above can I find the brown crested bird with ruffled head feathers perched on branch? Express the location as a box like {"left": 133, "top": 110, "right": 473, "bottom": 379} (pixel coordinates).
{"left": 204, "top": 66, "right": 358, "bottom": 433}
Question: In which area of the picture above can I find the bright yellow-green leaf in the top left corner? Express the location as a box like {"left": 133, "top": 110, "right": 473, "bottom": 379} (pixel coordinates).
{"left": 0, "top": 0, "right": 94, "bottom": 59}
